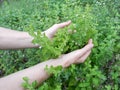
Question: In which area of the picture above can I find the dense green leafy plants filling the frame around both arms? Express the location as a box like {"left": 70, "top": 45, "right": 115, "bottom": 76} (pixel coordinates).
{"left": 0, "top": 0, "right": 120, "bottom": 90}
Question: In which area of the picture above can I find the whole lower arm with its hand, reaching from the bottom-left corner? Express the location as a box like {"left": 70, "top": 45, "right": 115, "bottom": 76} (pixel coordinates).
{"left": 0, "top": 40, "right": 93, "bottom": 90}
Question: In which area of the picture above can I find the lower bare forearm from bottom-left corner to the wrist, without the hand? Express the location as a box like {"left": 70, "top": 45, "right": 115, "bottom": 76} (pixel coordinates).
{"left": 0, "top": 59, "right": 64, "bottom": 90}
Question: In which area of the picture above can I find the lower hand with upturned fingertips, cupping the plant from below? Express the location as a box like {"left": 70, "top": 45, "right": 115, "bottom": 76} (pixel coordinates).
{"left": 59, "top": 39, "right": 93, "bottom": 67}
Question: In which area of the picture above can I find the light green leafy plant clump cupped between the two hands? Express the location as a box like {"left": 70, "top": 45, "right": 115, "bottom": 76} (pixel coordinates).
{"left": 30, "top": 6, "right": 97, "bottom": 60}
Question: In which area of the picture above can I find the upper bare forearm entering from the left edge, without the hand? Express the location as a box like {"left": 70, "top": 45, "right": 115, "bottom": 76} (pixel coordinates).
{"left": 0, "top": 27, "right": 39, "bottom": 49}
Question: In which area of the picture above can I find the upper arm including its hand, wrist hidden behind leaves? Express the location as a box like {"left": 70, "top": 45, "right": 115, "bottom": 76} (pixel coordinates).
{"left": 0, "top": 21, "right": 71, "bottom": 49}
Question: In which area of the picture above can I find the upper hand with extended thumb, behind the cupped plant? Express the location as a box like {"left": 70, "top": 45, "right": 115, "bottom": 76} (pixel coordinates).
{"left": 44, "top": 21, "right": 71, "bottom": 39}
